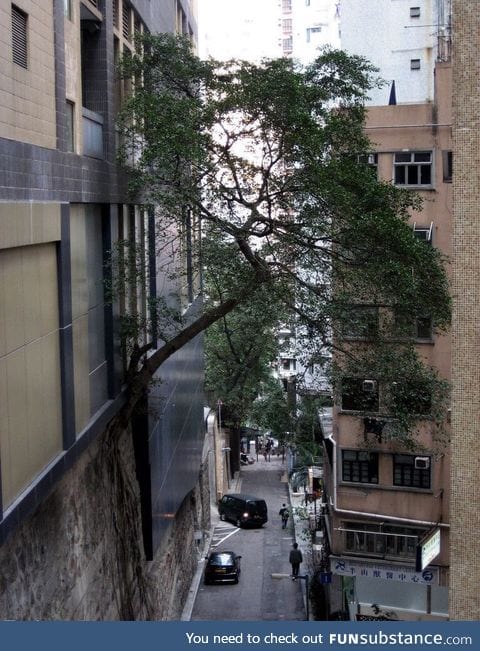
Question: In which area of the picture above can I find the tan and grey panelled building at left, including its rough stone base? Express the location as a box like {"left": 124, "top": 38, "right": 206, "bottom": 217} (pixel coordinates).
{"left": 0, "top": 0, "right": 208, "bottom": 619}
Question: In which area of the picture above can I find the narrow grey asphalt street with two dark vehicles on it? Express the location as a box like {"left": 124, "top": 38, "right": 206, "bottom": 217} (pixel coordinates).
{"left": 191, "top": 457, "right": 305, "bottom": 621}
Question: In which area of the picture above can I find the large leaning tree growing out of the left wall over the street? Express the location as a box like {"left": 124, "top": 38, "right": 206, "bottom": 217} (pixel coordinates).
{"left": 114, "top": 34, "right": 450, "bottom": 448}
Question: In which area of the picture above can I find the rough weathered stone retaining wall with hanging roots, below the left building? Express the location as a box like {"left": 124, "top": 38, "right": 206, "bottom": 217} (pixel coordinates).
{"left": 0, "top": 428, "right": 210, "bottom": 621}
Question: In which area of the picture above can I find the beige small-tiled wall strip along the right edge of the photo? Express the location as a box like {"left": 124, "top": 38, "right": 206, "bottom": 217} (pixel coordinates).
{"left": 449, "top": 0, "right": 480, "bottom": 620}
